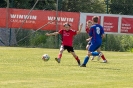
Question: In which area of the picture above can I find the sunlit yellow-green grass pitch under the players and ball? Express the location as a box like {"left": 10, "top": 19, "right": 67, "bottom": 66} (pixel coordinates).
{"left": 0, "top": 47, "right": 133, "bottom": 88}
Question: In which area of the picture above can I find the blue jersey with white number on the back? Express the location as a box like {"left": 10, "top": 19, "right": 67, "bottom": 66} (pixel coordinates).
{"left": 89, "top": 24, "right": 104, "bottom": 44}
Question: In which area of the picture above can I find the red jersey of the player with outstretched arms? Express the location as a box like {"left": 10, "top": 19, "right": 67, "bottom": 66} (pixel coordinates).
{"left": 59, "top": 29, "right": 77, "bottom": 46}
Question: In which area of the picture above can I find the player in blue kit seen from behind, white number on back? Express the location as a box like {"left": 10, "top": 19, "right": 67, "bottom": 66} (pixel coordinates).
{"left": 80, "top": 16, "right": 105, "bottom": 67}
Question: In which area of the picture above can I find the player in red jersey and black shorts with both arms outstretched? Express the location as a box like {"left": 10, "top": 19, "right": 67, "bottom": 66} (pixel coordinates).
{"left": 46, "top": 23, "right": 83, "bottom": 65}
